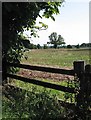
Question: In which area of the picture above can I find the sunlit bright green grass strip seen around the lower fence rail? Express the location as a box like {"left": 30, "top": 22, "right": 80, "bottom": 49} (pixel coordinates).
{"left": 11, "top": 79, "right": 75, "bottom": 103}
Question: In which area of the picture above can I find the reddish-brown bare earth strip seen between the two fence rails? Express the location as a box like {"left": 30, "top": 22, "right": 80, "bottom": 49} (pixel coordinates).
{"left": 18, "top": 69, "right": 74, "bottom": 81}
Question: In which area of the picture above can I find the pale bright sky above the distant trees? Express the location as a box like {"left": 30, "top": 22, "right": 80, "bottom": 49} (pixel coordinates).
{"left": 23, "top": 0, "right": 89, "bottom": 45}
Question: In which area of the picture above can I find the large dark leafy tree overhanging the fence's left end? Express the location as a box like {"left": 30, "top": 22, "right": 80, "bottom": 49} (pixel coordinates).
{"left": 2, "top": 0, "right": 63, "bottom": 81}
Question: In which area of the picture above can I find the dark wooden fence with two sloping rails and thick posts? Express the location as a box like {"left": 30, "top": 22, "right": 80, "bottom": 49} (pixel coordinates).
{"left": 3, "top": 61, "right": 91, "bottom": 111}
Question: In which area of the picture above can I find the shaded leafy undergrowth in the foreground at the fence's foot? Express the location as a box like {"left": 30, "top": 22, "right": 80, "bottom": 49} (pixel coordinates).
{"left": 2, "top": 86, "right": 87, "bottom": 120}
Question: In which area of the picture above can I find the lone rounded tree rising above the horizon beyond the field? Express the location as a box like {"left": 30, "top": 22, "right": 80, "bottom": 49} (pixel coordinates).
{"left": 49, "top": 32, "right": 65, "bottom": 48}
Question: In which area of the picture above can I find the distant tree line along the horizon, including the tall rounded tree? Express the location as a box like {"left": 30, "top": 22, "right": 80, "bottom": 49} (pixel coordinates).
{"left": 21, "top": 32, "right": 91, "bottom": 49}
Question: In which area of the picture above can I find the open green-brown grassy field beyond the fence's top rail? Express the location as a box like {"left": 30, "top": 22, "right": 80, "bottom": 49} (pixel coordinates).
{"left": 22, "top": 49, "right": 91, "bottom": 68}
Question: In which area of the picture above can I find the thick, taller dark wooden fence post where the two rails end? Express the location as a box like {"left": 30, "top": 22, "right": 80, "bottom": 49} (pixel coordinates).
{"left": 73, "top": 60, "right": 84, "bottom": 116}
